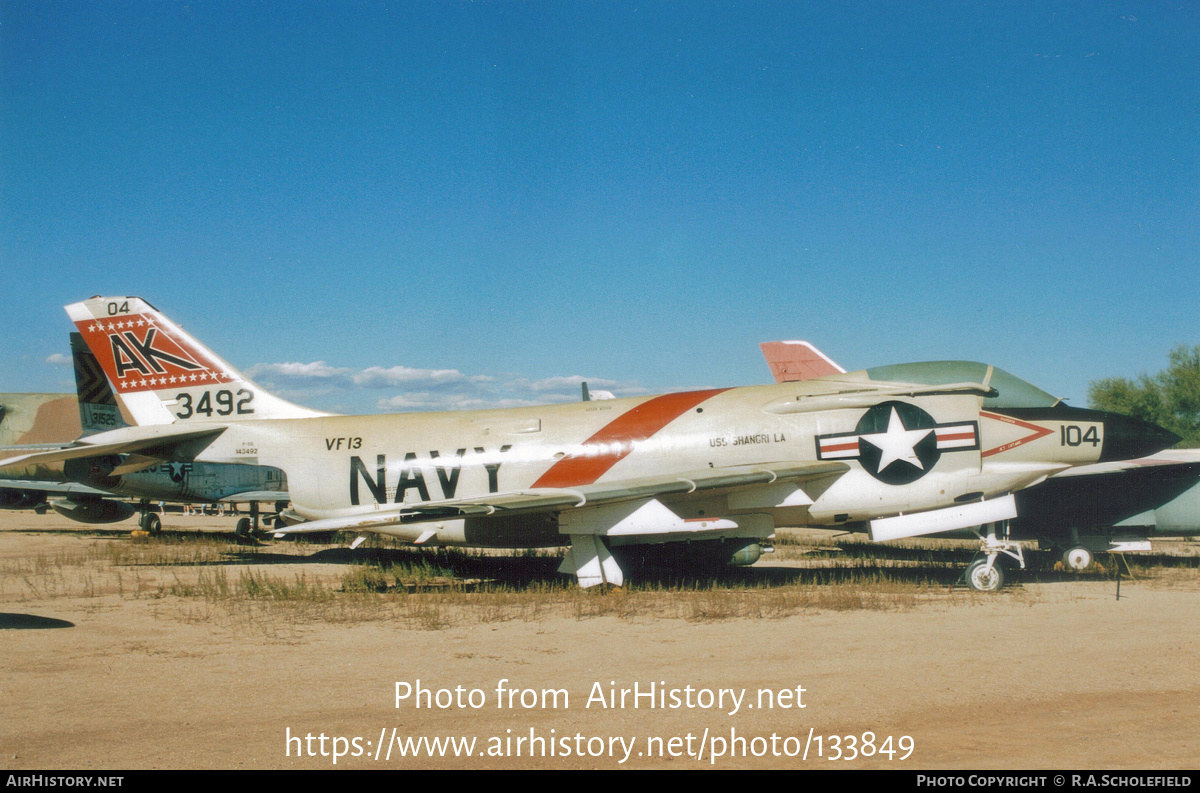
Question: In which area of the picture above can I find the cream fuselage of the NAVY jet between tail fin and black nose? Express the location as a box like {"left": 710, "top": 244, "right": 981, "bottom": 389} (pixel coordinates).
{"left": 177, "top": 376, "right": 1152, "bottom": 545}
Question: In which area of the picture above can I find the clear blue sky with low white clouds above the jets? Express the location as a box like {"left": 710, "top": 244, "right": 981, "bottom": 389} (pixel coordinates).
{"left": 0, "top": 0, "right": 1200, "bottom": 411}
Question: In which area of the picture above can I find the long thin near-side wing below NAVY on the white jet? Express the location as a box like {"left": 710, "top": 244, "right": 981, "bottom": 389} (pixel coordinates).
{"left": 267, "top": 461, "right": 850, "bottom": 534}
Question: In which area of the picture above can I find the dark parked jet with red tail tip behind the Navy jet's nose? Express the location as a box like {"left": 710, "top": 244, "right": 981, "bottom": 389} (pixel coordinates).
{"left": 760, "top": 341, "right": 1200, "bottom": 587}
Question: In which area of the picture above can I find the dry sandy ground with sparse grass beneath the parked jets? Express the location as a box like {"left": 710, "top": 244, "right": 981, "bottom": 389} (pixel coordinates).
{"left": 0, "top": 512, "right": 1200, "bottom": 769}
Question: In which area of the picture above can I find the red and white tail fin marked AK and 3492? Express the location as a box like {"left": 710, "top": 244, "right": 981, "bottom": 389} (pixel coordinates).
{"left": 66, "top": 296, "right": 329, "bottom": 425}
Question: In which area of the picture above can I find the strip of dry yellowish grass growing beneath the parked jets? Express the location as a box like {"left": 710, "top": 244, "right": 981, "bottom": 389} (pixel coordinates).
{"left": 7, "top": 531, "right": 1200, "bottom": 639}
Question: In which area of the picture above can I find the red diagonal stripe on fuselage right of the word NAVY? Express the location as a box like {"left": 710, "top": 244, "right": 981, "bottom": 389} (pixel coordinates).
{"left": 533, "top": 389, "right": 728, "bottom": 487}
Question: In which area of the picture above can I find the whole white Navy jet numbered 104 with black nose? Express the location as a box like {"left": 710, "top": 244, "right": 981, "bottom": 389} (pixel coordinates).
{"left": 0, "top": 296, "right": 1176, "bottom": 588}
